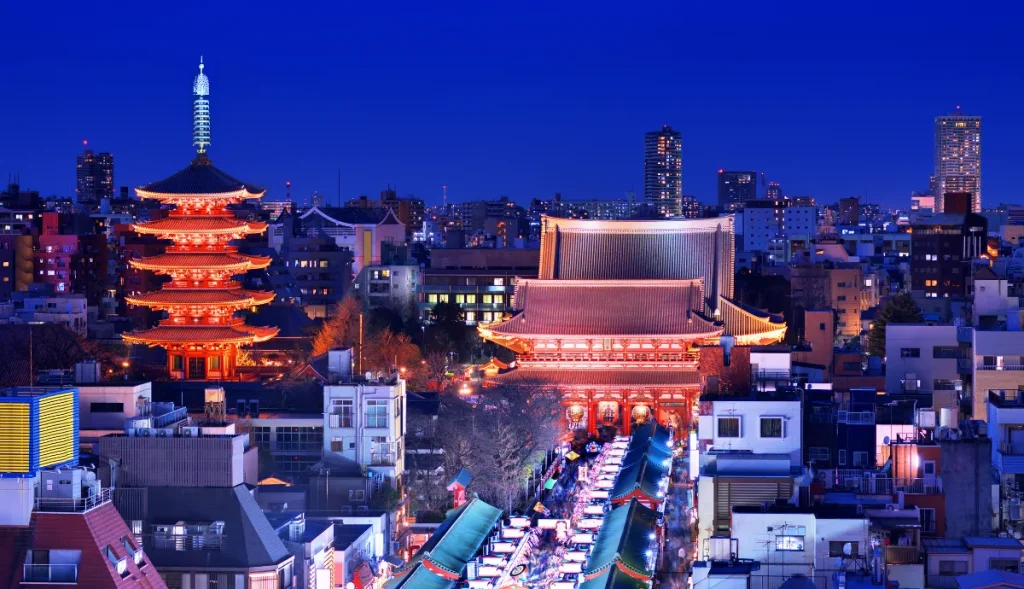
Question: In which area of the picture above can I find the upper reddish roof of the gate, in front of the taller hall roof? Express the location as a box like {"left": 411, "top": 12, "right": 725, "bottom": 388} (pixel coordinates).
{"left": 483, "top": 280, "right": 722, "bottom": 337}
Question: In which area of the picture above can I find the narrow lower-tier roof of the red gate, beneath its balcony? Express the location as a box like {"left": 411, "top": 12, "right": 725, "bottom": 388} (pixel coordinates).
{"left": 487, "top": 365, "right": 700, "bottom": 387}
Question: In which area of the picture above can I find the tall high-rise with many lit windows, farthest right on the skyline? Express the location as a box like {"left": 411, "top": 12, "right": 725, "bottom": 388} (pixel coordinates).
{"left": 935, "top": 107, "right": 981, "bottom": 213}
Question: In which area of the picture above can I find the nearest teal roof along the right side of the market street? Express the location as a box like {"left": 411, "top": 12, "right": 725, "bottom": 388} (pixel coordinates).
{"left": 584, "top": 499, "right": 662, "bottom": 587}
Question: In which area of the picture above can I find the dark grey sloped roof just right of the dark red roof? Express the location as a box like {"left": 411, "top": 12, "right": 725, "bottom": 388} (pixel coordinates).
{"left": 134, "top": 485, "right": 292, "bottom": 570}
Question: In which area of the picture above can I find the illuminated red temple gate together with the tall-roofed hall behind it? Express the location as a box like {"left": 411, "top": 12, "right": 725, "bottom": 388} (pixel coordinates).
{"left": 479, "top": 217, "right": 786, "bottom": 434}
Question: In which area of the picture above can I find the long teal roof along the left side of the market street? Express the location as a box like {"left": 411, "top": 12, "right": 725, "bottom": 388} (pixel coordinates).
{"left": 384, "top": 497, "right": 502, "bottom": 589}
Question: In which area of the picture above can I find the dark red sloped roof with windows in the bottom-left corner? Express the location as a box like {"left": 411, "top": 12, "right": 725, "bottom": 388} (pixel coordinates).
{"left": 0, "top": 503, "right": 167, "bottom": 589}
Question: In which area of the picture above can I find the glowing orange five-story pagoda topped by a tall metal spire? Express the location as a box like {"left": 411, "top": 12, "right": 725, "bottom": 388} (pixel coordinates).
{"left": 123, "top": 61, "right": 278, "bottom": 380}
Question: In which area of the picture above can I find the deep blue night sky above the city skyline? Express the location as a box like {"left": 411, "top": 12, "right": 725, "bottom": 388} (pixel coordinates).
{"left": 0, "top": 0, "right": 1024, "bottom": 205}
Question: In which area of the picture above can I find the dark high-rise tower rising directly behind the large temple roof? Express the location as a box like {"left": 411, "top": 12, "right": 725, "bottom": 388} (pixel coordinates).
{"left": 643, "top": 125, "right": 683, "bottom": 217}
